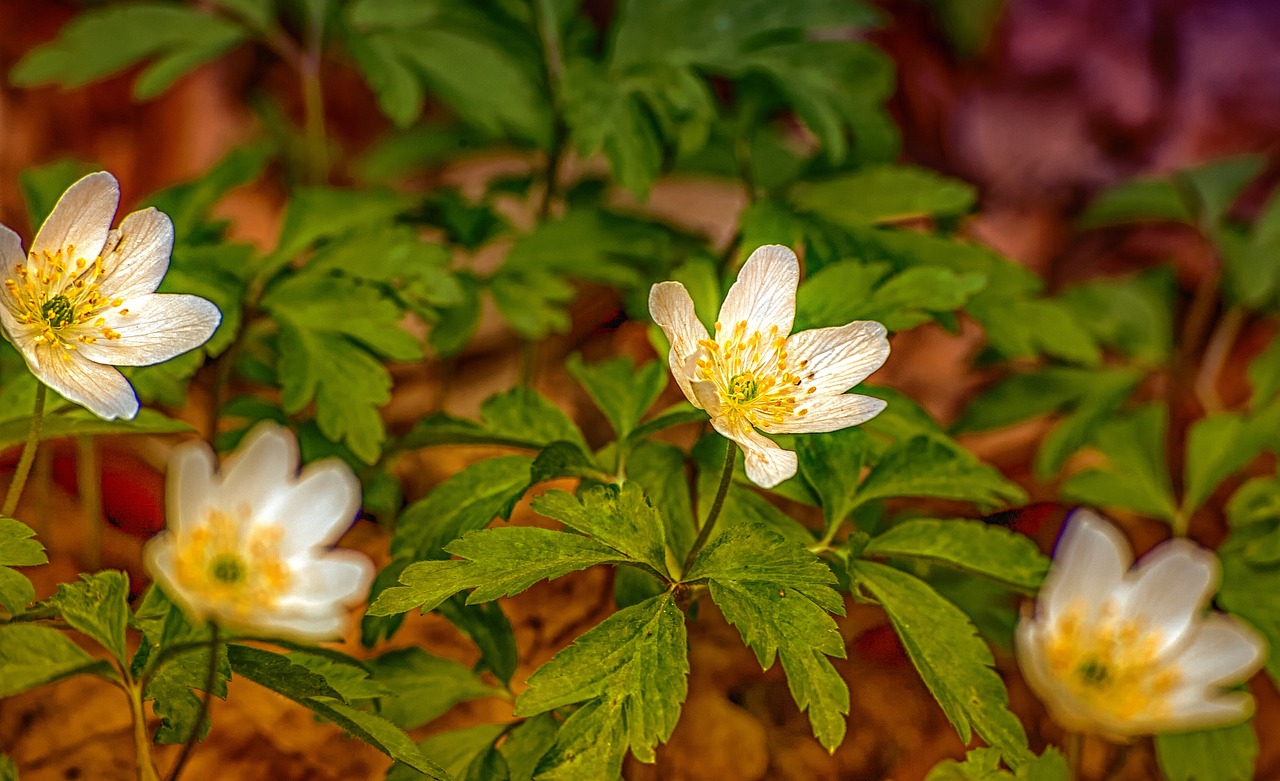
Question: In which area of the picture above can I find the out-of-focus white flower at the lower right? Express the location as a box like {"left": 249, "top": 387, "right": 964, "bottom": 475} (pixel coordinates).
{"left": 1016, "top": 510, "right": 1266, "bottom": 741}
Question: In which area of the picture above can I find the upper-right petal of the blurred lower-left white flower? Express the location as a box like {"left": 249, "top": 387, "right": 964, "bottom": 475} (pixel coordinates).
{"left": 256, "top": 458, "right": 360, "bottom": 557}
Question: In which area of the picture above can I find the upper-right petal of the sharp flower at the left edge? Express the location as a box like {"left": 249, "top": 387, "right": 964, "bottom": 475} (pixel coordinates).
{"left": 99, "top": 209, "right": 173, "bottom": 298}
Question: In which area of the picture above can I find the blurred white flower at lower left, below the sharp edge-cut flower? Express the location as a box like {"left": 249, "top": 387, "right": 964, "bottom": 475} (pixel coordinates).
{"left": 145, "top": 423, "right": 374, "bottom": 640}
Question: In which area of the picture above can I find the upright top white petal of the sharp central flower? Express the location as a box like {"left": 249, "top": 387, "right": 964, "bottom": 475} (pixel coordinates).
{"left": 719, "top": 245, "right": 793, "bottom": 338}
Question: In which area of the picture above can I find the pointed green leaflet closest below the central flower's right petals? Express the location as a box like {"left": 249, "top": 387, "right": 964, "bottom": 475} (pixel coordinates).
{"left": 855, "top": 435, "right": 1027, "bottom": 507}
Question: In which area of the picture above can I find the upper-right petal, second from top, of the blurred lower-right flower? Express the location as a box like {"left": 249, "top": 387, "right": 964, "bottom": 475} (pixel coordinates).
{"left": 1121, "top": 539, "right": 1219, "bottom": 653}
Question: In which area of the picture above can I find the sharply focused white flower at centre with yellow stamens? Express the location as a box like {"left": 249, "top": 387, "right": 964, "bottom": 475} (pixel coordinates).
{"left": 649, "top": 245, "right": 888, "bottom": 488}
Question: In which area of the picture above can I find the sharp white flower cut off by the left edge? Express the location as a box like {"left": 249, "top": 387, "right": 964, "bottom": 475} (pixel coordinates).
{"left": 0, "top": 172, "right": 221, "bottom": 420}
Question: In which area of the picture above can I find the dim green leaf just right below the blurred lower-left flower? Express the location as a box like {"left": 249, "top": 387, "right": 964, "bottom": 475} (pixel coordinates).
{"left": 367, "top": 648, "right": 502, "bottom": 730}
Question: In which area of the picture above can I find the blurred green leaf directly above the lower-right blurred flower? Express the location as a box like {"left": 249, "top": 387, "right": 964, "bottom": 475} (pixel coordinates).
{"left": 1061, "top": 403, "right": 1178, "bottom": 522}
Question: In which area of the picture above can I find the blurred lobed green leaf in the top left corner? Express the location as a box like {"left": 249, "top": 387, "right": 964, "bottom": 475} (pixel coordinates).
{"left": 9, "top": 3, "right": 247, "bottom": 100}
